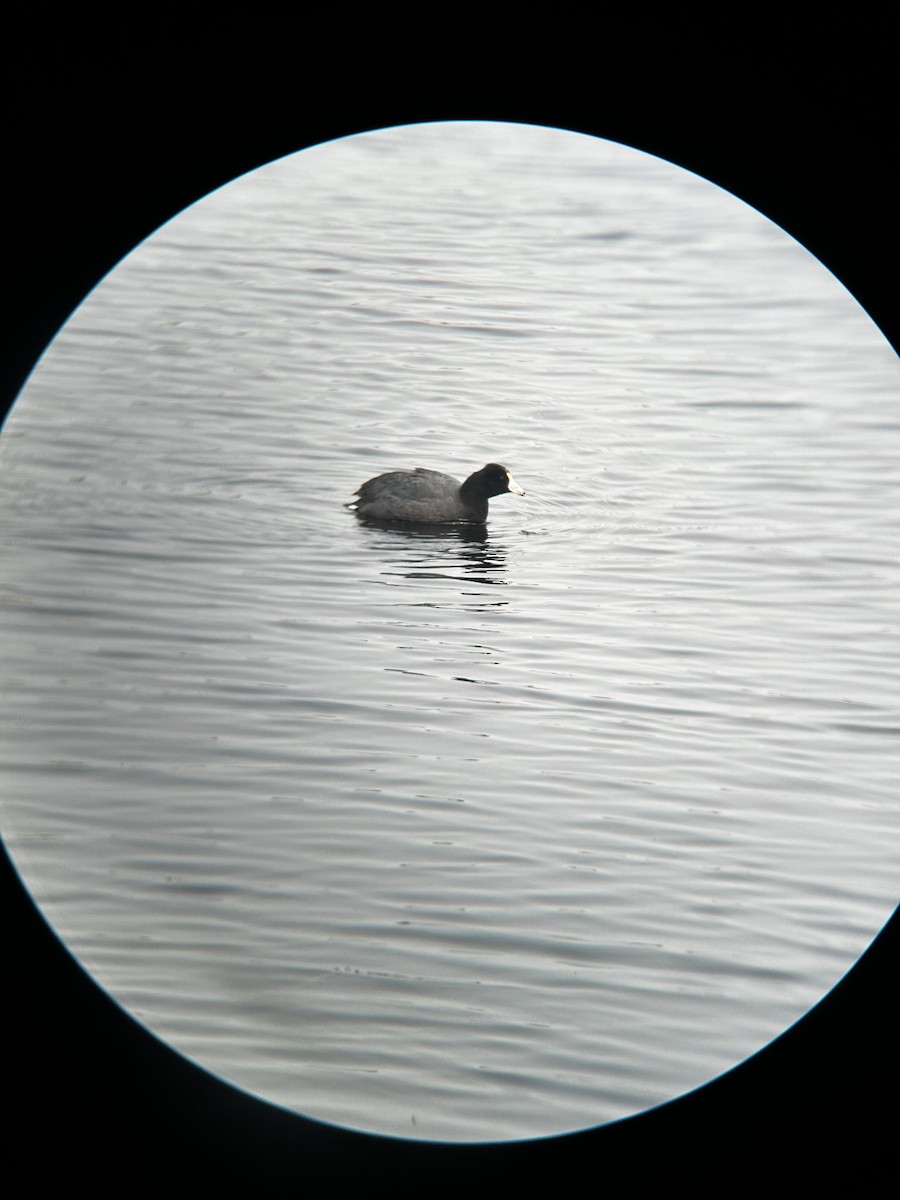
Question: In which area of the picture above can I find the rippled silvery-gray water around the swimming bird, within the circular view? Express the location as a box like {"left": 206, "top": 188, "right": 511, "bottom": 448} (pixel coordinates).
{"left": 0, "top": 125, "right": 900, "bottom": 1140}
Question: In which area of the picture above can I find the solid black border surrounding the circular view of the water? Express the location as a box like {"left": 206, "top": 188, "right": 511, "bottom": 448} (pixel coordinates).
{"left": 0, "top": 14, "right": 900, "bottom": 1195}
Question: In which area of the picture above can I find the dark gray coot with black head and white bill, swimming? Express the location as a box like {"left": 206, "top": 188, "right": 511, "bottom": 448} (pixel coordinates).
{"left": 355, "top": 462, "right": 524, "bottom": 524}
